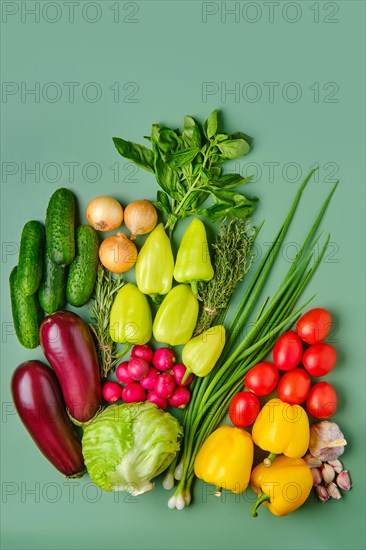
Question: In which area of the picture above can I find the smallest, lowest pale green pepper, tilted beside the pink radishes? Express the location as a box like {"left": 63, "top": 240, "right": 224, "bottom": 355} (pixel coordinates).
{"left": 182, "top": 325, "right": 225, "bottom": 382}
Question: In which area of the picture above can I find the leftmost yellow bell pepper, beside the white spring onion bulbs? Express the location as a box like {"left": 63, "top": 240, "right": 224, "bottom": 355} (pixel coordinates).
{"left": 194, "top": 426, "right": 254, "bottom": 496}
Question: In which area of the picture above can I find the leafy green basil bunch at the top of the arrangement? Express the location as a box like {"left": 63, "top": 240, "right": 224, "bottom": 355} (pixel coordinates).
{"left": 113, "top": 109, "right": 257, "bottom": 234}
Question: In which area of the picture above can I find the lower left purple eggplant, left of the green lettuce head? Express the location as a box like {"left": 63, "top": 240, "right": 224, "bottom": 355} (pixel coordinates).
{"left": 11, "top": 361, "right": 85, "bottom": 477}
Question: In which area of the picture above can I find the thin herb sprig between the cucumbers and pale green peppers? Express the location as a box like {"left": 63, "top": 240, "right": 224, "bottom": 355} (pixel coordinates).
{"left": 89, "top": 264, "right": 124, "bottom": 378}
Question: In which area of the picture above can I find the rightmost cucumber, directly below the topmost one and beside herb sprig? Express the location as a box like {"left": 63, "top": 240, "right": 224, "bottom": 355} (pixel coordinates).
{"left": 66, "top": 225, "right": 99, "bottom": 307}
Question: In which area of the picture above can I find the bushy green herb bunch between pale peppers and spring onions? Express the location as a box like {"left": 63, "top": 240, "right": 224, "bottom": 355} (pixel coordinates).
{"left": 195, "top": 218, "right": 257, "bottom": 334}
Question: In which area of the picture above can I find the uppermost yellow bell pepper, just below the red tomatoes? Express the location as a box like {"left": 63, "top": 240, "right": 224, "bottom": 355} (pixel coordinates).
{"left": 252, "top": 397, "right": 310, "bottom": 466}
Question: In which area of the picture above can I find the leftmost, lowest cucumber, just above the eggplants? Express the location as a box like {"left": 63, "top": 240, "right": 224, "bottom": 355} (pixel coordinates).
{"left": 9, "top": 266, "right": 41, "bottom": 349}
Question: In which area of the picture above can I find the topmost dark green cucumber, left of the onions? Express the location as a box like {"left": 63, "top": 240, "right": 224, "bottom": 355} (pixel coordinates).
{"left": 46, "top": 187, "right": 75, "bottom": 265}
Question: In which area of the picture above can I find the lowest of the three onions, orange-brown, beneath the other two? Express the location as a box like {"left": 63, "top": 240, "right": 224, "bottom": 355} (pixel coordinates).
{"left": 99, "top": 232, "right": 137, "bottom": 273}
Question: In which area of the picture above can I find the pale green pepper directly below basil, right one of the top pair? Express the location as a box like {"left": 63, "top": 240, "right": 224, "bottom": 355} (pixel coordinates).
{"left": 174, "top": 218, "right": 214, "bottom": 294}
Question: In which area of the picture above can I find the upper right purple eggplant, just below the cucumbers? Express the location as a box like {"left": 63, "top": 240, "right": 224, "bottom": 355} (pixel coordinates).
{"left": 40, "top": 311, "right": 101, "bottom": 423}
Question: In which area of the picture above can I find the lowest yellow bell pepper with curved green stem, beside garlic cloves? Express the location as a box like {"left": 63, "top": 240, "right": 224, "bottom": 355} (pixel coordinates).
{"left": 250, "top": 456, "right": 313, "bottom": 517}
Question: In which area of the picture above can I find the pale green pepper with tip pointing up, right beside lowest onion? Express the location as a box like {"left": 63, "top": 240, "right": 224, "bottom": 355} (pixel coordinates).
{"left": 136, "top": 223, "right": 174, "bottom": 300}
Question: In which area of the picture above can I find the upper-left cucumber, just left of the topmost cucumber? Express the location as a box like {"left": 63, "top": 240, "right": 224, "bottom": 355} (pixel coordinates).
{"left": 17, "top": 220, "right": 44, "bottom": 295}
